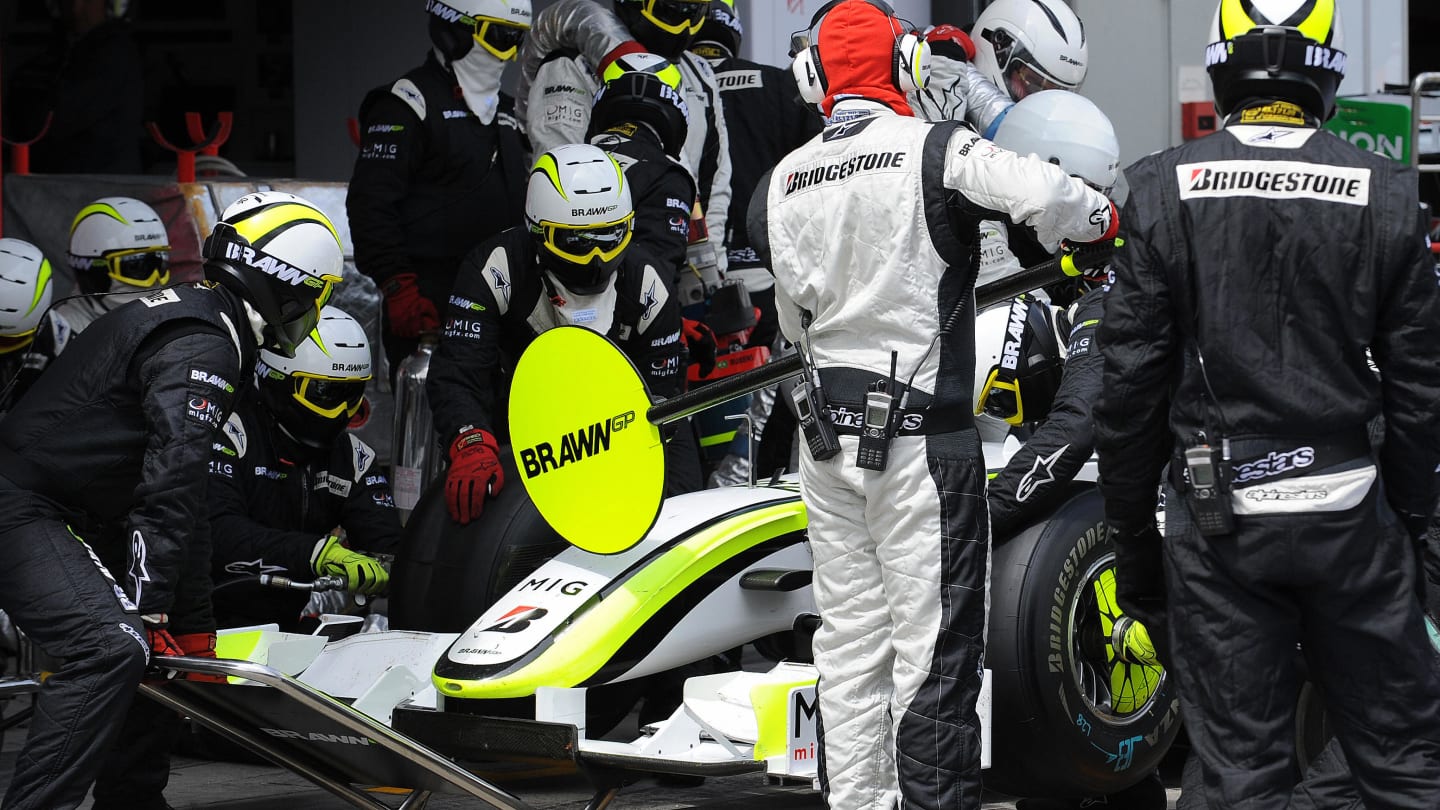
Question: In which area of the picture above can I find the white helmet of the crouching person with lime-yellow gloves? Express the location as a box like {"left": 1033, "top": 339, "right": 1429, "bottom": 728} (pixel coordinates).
{"left": 255, "top": 306, "right": 373, "bottom": 450}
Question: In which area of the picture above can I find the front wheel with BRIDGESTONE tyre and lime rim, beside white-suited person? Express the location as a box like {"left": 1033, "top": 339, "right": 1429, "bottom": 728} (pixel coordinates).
{"left": 985, "top": 487, "right": 1179, "bottom": 797}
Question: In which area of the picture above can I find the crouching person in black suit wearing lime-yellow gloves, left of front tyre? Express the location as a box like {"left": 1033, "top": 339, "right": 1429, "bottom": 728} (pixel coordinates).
{"left": 207, "top": 307, "right": 400, "bottom": 631}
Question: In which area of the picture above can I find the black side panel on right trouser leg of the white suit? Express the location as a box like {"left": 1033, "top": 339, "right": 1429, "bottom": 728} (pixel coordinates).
{"left": 896, "top": 446, "right": 989, "bottom": 810}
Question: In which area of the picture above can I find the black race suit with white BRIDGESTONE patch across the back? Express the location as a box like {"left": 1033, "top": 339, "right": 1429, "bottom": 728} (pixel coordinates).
{"left": 1094, "top": 104, "right": 1440, "bottom": 809}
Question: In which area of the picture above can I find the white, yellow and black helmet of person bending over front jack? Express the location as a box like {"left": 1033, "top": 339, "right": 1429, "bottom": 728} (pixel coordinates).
{"left": 202, "top": 192, "right": 344, "bottom": 357}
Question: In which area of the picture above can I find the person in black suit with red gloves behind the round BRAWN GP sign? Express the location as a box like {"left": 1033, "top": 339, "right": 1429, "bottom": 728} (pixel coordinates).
{"left": 426, "top": 144, "right": 700, "bottom": 525}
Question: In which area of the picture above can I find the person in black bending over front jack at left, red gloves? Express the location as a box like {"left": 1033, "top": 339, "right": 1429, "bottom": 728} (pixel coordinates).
{"left": 0, "top": 192, "right": 343, "bottom": 809}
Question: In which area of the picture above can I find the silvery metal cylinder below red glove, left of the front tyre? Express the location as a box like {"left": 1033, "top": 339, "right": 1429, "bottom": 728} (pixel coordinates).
{"left": 390, "top": 331, "right": 445, "bottom": 525}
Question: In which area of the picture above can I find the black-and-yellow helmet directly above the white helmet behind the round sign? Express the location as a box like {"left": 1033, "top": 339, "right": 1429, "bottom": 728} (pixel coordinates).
{"left": 590, "top": 53, "right": 690, "bottom": 159}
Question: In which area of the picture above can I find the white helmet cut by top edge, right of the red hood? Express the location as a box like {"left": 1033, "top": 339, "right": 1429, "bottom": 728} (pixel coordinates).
{"left": 971, "top": 0, "right": 1090, "bottom": 101}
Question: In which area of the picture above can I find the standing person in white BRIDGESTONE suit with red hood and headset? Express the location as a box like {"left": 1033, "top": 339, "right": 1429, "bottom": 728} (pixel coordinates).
{"left": 768, "top": 0, "right": 1119, "bottom": 809}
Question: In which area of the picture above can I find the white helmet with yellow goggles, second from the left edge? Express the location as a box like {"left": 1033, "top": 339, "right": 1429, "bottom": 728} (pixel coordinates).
{"left": 69, "top": 197, "right": 170, "bottom": 294}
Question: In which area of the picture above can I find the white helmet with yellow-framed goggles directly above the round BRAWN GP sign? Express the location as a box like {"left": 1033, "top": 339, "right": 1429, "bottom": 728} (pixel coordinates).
{"left": 526, "top": 144, "right": 635, "bottom": 295}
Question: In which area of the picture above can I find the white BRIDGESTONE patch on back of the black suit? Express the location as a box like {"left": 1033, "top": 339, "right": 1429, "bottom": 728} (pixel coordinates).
{"left": 1175, "top": 160, "right": 1369, "bottom": 206}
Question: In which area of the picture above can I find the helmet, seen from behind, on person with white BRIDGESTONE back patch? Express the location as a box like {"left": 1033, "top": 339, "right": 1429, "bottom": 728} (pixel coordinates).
{"left": 1205, "top": 0, "right": 1346, "bottom": 121}
